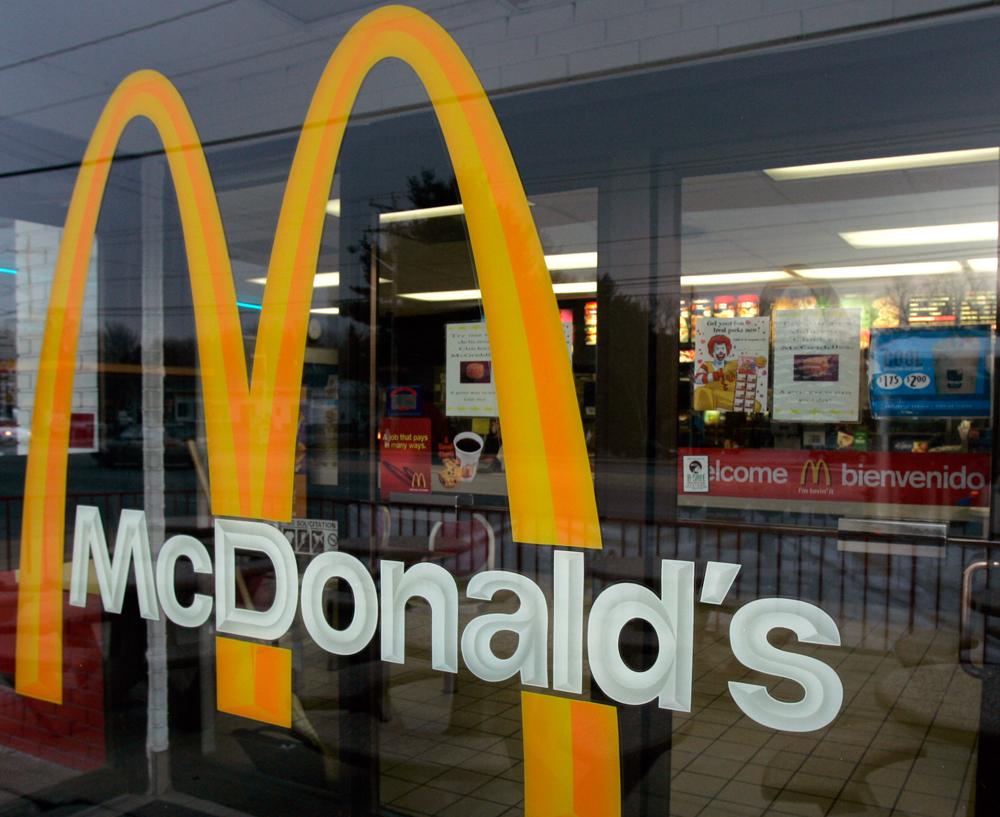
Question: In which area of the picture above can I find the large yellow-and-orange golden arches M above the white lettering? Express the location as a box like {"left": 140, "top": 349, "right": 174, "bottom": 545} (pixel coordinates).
{"left": 16, "top": 6, "right": 601, "bottom": 702}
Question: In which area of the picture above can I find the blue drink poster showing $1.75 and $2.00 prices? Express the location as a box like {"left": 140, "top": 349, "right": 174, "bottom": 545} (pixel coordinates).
{"left": 868, "top": 326, "right": 992, "bottom": 417}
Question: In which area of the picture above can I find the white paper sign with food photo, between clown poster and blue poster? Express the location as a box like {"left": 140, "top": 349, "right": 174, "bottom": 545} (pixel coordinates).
{"left": 774, "top": 308, "right": 861, "bottom": 423}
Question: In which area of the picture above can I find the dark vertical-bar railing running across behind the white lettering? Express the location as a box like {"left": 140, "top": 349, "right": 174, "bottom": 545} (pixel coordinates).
{"left": 0, "top": 490, "right": 1000, "bottom": 638}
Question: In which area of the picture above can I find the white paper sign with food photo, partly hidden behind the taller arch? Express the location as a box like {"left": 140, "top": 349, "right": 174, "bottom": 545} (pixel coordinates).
{"left": 444, "top": 321, "right": 573, "bottom": 417}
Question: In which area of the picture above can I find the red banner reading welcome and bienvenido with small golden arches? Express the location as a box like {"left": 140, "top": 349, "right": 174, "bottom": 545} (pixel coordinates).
{"left": 678, "top": 448, "right": 990, "bottom": 507}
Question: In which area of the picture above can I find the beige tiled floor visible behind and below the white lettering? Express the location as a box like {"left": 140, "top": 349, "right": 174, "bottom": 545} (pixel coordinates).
{"left": 381, "top": 607, "right": 979, "bottom": 817}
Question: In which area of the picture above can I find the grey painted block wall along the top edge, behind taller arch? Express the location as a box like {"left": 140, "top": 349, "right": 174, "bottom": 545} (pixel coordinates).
{"left": 179, "top": 0, "right": 989, "bottom": 141}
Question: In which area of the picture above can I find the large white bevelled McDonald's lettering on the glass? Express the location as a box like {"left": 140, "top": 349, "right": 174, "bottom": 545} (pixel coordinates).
{"left": 69, "top": 505, "right": 843, "bottom": 732}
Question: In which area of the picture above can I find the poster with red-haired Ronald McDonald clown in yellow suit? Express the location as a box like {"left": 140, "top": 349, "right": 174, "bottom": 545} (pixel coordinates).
{"left": 692, "top": 318, "right": 771, "bottom": 414}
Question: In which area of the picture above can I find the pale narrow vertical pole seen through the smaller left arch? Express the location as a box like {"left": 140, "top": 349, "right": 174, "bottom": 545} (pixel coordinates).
{"left": 141, "top": 156, "right": 170, "bottom": 794}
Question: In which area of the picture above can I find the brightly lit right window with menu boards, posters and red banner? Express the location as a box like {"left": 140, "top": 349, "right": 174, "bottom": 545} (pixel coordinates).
{"left": 678, "top": 155, "right": 998, "bottom": 536}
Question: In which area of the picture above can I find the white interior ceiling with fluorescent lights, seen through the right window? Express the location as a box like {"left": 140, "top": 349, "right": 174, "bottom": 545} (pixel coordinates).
{"left": 681, "top": 162, "right": 998, "bottom": 282}
